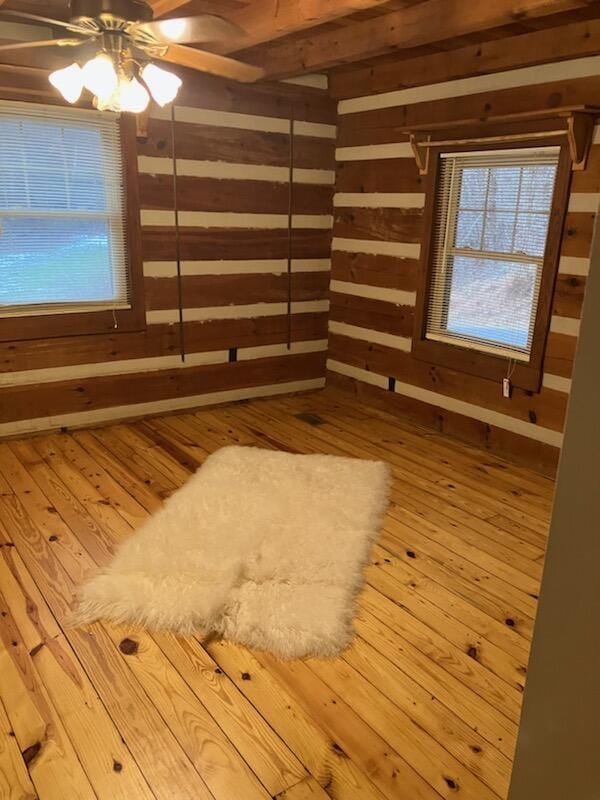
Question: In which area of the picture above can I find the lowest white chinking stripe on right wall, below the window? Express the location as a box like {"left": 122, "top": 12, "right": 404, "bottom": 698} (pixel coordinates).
{"left": 327, "top": 359, "right": 562, "bottom": 447}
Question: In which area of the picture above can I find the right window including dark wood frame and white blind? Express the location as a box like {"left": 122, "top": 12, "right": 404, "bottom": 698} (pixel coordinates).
{"left": 413, "top": 138, "right": 568, "bottom": 389}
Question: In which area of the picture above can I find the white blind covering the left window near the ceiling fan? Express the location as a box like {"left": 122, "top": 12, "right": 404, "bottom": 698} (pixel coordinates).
{"left": 0, "top": 101, "right": 130, "bottom": 316}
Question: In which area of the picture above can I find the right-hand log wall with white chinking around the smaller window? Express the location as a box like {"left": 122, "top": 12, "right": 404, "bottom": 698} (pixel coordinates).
{"left": 328, "top": 58, "right": 600, "bottom": 482}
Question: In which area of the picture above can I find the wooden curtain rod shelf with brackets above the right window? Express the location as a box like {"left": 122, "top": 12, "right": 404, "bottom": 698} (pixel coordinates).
{"left": 405, "top": 106, "right": 600, "bottom": 175}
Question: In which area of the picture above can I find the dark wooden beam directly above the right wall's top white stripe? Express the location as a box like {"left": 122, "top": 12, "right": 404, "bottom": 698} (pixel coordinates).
{"left": 329, "top": 20, "right": 600, "bottom": 100}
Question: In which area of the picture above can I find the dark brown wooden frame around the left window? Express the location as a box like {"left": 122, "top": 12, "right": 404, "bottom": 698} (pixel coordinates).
{"left": 0, "top": 108, "right": 146, "bottom": 342}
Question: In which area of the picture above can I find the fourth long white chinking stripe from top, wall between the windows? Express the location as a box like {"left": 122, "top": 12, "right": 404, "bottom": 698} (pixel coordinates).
{"left": 144, "top": 258, "right": 331, "bottom": 278}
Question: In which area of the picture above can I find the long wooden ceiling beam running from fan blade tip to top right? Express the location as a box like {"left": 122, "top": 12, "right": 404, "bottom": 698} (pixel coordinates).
{"left": 244, "top": 0, "right": 597, "bottom": 78}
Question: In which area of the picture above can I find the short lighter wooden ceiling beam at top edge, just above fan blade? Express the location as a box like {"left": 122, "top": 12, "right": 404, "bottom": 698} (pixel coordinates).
{"left": 213, "top": 0, "right": 387, "bottom": 53}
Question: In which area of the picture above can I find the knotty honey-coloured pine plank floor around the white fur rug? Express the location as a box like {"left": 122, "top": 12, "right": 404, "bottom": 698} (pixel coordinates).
{"left": 0, "top": 389, "right": 553, "bottom": 800}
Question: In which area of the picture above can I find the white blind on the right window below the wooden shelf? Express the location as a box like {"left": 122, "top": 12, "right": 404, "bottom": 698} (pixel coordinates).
{"left": 426, "top": 147, "right": 559, "bottom": 361}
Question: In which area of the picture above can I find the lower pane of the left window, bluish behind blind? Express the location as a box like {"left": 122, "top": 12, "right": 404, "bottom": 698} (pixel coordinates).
{"left": 0, "top": 217, "right": 117, "bottom": 306}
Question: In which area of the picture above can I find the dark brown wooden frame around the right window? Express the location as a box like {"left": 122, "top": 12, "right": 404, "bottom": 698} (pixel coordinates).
{"left": 411, "top": 135, "right": 572, "bottom": 392}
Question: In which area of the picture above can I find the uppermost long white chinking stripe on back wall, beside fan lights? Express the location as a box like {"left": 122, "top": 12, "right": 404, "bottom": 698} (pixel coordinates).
{"left": 150, "top": 106, "right": 337, "bottom": 139}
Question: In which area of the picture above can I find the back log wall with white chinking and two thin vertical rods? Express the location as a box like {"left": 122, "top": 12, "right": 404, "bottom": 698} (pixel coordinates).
{"left": 0, "top": 73, "right": 336, "bottom": 436}
